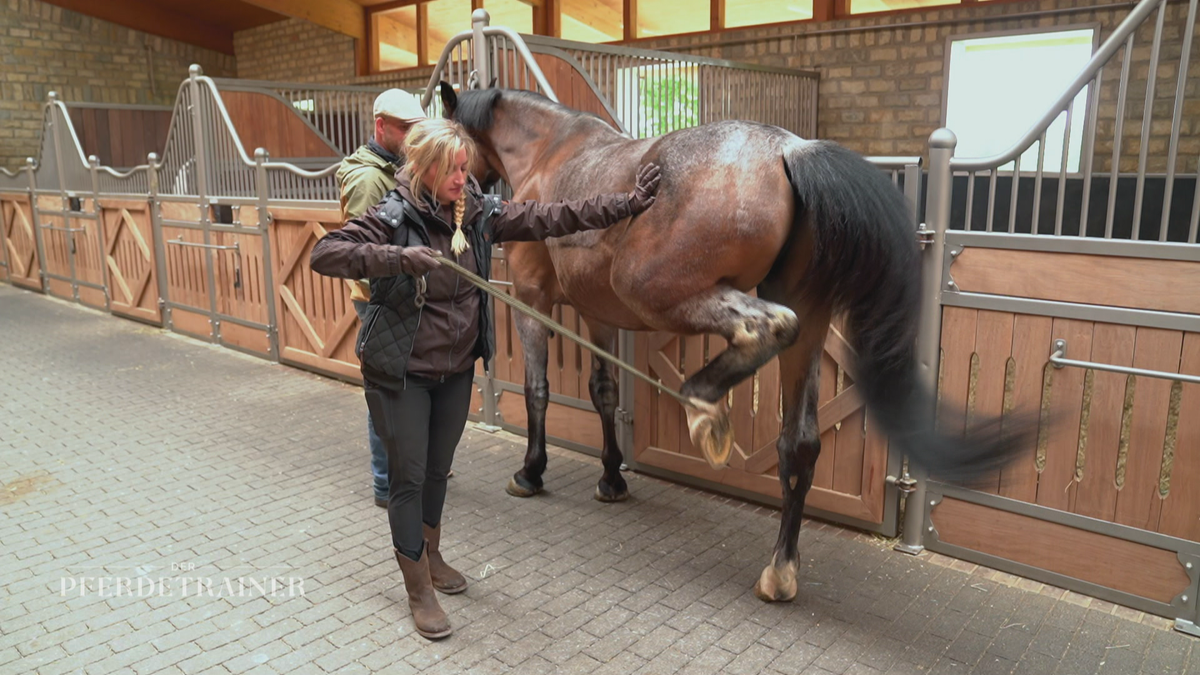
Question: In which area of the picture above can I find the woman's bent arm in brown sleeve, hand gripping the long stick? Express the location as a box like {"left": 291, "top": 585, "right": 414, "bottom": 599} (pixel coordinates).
{"left": 308, "top": 200, "right": 438, "bottom": 279}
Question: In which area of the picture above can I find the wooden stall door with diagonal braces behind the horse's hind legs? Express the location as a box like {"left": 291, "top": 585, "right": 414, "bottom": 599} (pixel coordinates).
{"left": 634, "top": 317, "right": 888, "bottom": 525}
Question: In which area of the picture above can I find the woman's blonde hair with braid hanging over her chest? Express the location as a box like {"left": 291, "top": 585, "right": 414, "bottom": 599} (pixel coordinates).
{"left": 403, "top": 119, "right": 475, "bottom": 256}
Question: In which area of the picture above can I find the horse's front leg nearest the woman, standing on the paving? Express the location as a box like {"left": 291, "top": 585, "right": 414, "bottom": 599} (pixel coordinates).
{"left": 506, "top": 307, "right": 550, "bottom": 497}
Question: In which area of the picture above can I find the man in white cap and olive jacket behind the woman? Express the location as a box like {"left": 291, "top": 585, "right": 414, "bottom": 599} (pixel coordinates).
{"left": 337, "top": 89, "right": 425, "bottom": 508}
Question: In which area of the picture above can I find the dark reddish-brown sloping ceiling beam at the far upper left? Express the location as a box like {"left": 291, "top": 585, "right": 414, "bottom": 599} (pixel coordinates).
{"left": 35, "top": 0, "right": 233, "bottom": 54}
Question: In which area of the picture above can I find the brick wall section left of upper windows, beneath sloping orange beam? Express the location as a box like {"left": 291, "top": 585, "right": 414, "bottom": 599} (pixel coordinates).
{"left": 233, "top": 19, "right": 354, "bottom": 83}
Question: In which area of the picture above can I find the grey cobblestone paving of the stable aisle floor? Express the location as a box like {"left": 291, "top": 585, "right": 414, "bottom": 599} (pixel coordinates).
{"left": 0, "top": 286, "right": 1200, "bottom": 675}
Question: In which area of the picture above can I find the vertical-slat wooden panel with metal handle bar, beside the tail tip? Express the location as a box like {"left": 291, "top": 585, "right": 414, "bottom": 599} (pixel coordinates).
{"left": 940, "top": 294, "right": 1200, "bottom": 540}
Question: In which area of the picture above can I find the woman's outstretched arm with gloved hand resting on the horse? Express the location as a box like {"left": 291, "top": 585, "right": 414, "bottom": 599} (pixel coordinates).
{"left": 482, "top": 165, "right": 659, "bottom": 241}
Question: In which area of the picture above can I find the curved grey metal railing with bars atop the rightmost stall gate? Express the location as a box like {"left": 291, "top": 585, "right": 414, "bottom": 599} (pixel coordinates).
{"left": 950, "top": 0, "right": 1200, "bottom": 244}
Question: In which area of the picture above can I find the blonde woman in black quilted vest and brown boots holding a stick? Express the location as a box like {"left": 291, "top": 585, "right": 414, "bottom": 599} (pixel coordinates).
{"left": 311, "top": 119, "right": 659, "bottom": 639}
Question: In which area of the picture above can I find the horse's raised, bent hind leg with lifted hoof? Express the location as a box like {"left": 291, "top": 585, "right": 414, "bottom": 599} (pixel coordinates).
{"left": 666, "top": 286, "right": 799, "bottom": 467}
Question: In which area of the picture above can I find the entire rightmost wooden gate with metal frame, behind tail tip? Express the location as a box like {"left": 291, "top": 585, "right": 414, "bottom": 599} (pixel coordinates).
{"left": 925, "top": 237, "right": 1200, "bottom": 616}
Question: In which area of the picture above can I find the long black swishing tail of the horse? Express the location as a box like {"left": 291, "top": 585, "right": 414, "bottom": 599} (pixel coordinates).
{"left": 784, "top": 141, "right": 1031, "bottom": 483}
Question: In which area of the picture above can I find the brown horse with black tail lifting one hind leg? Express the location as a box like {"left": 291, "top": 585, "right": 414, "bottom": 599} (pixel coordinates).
{"left": 440, "top": 84, "right": 1021, "bottom": 601}
